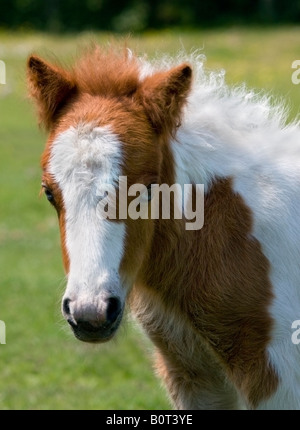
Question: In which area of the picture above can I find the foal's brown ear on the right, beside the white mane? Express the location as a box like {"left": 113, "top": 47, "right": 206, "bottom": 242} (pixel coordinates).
{"left": 137, "top": 64, "right": 192, "bottom": 136}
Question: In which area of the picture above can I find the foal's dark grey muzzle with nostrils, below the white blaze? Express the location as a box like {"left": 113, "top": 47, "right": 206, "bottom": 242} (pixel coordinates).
{"left": 62, "top": 296, "right": 123, "bottom": 343}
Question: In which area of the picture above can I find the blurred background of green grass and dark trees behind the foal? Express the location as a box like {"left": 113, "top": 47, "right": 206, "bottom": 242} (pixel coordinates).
{"left": 0, "top": 0, "right": 300, "bottom": 410}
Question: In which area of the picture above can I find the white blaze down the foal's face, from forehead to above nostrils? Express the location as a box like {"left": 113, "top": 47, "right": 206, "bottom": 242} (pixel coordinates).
{"left": 49, "top": 124, "right": 126, "bottom": 299}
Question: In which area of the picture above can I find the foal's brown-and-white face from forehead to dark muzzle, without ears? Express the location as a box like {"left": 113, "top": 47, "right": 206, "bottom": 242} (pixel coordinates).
{"left": 42, "top": 95, "right": 161, "bottom": 341}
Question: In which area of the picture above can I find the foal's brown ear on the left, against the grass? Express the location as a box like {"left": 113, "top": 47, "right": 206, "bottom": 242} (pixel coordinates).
{"left": 27, "top": 55, "right": 76, "bottom": 129}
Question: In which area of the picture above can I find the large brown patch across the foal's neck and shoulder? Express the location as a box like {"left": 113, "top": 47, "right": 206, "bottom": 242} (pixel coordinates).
{"left": 140, "top": 179, "right": 278, "bottom": 407}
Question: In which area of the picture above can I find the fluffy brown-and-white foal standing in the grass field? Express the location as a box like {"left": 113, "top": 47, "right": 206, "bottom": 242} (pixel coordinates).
{"left": 27, "top": 46, "right": 300, "bottom": 410}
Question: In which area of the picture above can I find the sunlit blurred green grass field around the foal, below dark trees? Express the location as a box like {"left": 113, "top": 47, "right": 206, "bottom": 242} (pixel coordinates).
{"left": 0, "top": 27, "right": 300, "bottom": 410}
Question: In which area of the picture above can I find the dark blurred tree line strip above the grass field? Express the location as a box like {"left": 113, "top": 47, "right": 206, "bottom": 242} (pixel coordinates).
{"left": 0, "top": 0, "right": 300, "bottom": 32}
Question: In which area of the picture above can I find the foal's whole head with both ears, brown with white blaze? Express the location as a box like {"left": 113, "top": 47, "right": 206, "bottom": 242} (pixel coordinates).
{"left": 28, "top": 47, "right": 191, "bottom": 342}
